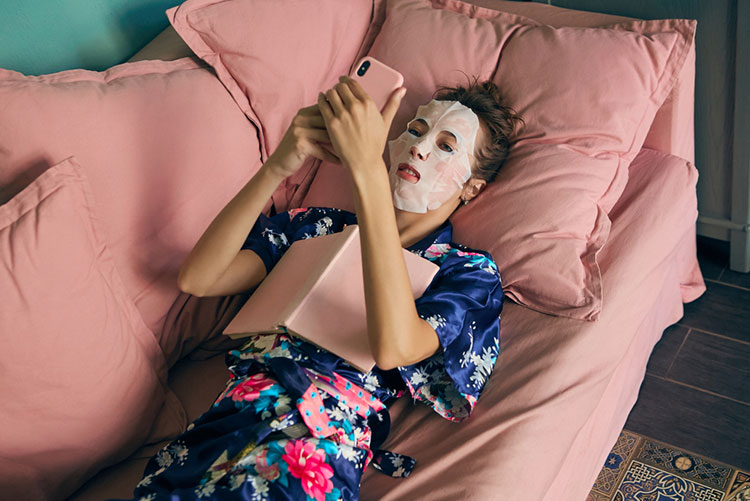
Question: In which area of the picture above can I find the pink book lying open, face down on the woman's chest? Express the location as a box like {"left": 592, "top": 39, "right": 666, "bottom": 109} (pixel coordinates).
{"left": 224, "top": 224, "right": 439, "bottom": 372}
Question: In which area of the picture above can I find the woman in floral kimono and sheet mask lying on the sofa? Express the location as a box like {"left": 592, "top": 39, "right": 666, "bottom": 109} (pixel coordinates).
{"left": 122, "top": 76, "right": 520, "bottom": 501}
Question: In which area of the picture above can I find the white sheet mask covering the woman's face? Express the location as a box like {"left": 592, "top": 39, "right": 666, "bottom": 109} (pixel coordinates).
{"left": 388, "top": 99, "right": 479, "bottom": 213}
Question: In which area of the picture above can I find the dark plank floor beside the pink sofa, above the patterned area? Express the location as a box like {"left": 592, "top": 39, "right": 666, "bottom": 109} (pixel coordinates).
{"left": 625, "top": 237, "right": 750, "bottom": 471}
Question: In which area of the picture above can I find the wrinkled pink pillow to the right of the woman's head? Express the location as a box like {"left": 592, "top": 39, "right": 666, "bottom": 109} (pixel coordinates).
{"left": 448, "top": 12, "right": 695, "bottom": 320}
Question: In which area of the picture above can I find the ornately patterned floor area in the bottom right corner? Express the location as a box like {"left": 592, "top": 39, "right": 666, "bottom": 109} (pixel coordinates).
{"left": 586, "top": 430, "right": 750, "bottom": 501}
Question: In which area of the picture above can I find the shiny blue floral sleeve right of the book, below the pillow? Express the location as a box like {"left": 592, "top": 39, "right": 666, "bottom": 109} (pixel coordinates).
{"left": 398, "top": 249, "right": 503, "bottom": 421}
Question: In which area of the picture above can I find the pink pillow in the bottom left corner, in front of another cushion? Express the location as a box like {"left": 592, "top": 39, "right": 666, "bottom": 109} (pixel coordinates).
{"left": 0, "top": 157, "right": 169, "bottom": 499}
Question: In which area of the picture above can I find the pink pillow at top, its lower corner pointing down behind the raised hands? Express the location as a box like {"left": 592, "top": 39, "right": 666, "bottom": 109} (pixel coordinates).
{"left": 166, "top": 0, "right": 372, "bottom": 162}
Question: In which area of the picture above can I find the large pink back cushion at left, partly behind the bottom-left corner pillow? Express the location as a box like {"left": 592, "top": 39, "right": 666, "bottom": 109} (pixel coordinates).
{"left": 0, "top": 58, "right": 271, "bottom": 352}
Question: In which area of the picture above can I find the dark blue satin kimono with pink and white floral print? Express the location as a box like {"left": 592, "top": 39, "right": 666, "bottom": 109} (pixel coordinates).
{"left": 117, "top": 207, "right": 503, "bottom": 501}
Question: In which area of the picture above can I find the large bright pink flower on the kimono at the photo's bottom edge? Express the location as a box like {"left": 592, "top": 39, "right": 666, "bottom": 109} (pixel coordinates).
{"left": 281, "top": 440, "right": 333, "bottom": 501}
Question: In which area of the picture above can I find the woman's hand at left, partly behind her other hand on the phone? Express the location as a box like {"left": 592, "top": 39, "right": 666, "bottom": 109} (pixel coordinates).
{"left": 266, "top": 103, "right": 341, "bottom": 178}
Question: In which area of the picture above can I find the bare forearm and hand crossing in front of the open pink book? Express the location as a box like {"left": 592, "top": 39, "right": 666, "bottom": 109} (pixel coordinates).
{"left": 318, "top": 75, "right": 440, "bottom": 370}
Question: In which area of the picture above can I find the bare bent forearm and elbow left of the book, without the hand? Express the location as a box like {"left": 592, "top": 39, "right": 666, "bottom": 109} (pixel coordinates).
{"left": 178, "top": 162, "right": 285, "bottom": 296}
